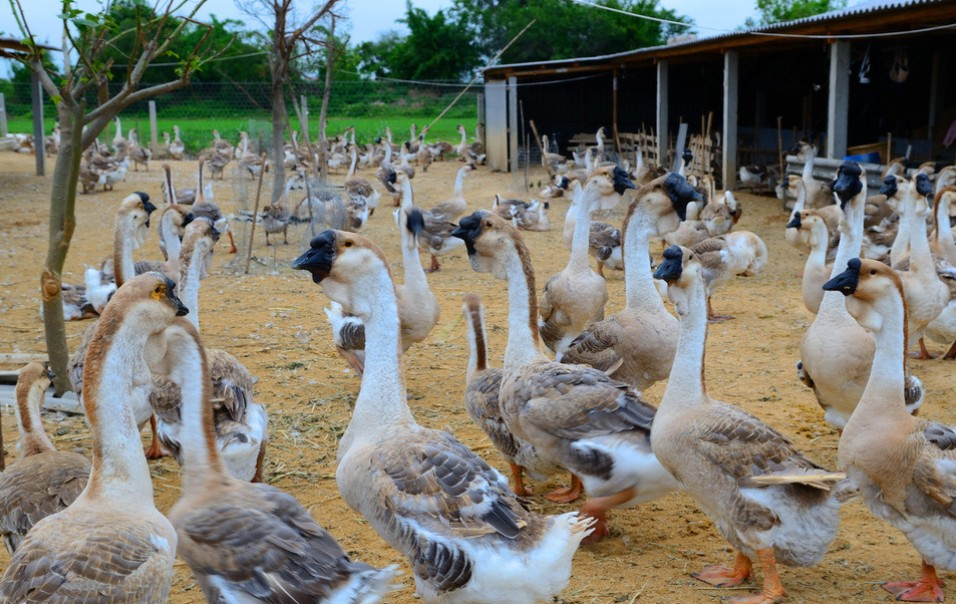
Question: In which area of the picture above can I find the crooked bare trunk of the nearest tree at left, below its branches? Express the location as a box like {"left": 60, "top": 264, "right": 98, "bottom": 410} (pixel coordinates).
{"left": 38, "top": 103, "right": 84, "bottom": 396}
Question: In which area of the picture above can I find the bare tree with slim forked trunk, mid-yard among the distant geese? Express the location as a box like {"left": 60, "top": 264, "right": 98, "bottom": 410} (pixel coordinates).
{"left": 237, "top": 0, "right": 339, "bottom": 204}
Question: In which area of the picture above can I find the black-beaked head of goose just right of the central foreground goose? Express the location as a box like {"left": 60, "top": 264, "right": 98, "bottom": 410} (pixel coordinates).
{"left": 451, "top": 210, "right": 527, "bottom": 279}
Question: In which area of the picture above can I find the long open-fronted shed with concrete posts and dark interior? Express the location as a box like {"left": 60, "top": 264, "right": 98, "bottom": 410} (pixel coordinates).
{"left": 483, "top": 0, "right": 956, "bottom": 187}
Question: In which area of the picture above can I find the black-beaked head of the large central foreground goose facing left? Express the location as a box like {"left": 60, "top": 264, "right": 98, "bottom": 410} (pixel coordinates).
{"left": 292, "top": 229, "right": 390, "bottom": 320}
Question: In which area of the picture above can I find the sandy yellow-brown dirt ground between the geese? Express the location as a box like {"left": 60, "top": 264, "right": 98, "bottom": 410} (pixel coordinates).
{"left": 0, "top": 153, "right": 956, "bottom": 604}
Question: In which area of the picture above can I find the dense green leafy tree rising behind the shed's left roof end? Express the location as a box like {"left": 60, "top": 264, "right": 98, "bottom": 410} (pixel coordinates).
{"left": 452, "top": 0, "right": 693, "bottom": 63}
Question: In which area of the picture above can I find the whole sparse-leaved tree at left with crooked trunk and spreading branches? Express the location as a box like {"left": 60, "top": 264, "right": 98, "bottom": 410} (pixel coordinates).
{"left": 11, "top": 0, "right": 227, "bottom": 394}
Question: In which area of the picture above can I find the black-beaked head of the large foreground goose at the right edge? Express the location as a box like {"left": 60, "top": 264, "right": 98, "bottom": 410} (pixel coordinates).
{"left": 823, "top": 258, "right": 906, "bottom": 342}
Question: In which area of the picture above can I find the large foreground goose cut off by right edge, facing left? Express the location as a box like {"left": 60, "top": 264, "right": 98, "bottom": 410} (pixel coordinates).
{"left": 824, "top": 258, "right": 956, "bottom": 602}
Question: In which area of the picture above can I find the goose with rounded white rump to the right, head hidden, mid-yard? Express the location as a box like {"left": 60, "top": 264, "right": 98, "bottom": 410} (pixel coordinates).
{"left": 691, "top": 231, "right": 767, "bottom": 322}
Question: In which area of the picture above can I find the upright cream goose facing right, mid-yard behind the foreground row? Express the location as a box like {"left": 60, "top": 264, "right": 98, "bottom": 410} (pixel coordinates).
{"left": 538, "top": 168, "right": 634, "bottom": 361}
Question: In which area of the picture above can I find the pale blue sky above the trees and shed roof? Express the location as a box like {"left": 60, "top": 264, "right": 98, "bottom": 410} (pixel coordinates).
{"left": 0, "top": 0, "right": 756, "bottom": 73}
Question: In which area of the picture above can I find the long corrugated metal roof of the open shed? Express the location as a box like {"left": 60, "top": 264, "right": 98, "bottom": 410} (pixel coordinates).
{"left": 484, "top": 0, "right": 956, "bottom": 77}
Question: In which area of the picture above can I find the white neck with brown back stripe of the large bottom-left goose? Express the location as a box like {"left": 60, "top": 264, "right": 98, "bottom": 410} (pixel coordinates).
{"left": 80, "top": 312, "right": 155, "bottom": 510}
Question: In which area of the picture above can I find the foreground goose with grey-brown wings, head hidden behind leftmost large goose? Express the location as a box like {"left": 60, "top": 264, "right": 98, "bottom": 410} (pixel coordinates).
{"left": 166, "top": 319, "right": 396, "bottom": 604}
